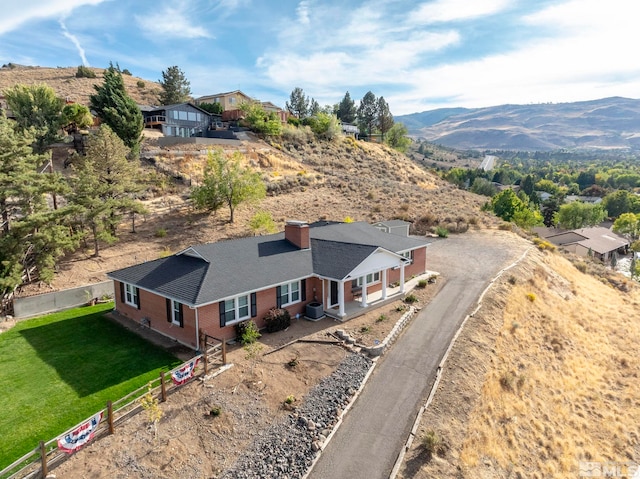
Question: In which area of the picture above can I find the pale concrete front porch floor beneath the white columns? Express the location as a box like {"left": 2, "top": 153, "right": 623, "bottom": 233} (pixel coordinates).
{"left": 324, "top": 271, "right": 440, "bottom": 321}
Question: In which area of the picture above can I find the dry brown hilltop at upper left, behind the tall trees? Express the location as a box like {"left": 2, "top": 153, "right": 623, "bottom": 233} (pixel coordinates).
{"left": 0, "top": 65, "right": 160, "bottom": 105}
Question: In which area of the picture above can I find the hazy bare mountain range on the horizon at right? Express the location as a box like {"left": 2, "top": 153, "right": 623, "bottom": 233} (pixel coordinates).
{"left": 395, "top": 97, "right": 640, "bottom": 150}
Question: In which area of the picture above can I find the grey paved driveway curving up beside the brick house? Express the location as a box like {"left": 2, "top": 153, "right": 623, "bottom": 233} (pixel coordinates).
{"left": 308, "top": 232, "right": 526, "bottom": 479}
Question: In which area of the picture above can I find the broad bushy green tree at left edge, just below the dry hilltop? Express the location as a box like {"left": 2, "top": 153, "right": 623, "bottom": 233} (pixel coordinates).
{"left": 4, "top": 85, "right": 64, "bottom": 153}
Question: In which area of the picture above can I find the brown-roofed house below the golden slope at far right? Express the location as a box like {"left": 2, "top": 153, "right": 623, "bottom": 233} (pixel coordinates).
{"left": 534, "top": 226, "right": 630, "bottom": 262}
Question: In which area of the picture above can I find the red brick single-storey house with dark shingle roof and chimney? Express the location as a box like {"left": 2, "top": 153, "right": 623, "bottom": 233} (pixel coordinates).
{"left": 108, "top": 221, "right": 428, "bottom": 349}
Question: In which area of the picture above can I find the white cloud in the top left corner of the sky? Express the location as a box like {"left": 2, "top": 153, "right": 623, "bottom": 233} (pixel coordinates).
{"left": 0, "top": 0, "right": 105, "bottom": 35}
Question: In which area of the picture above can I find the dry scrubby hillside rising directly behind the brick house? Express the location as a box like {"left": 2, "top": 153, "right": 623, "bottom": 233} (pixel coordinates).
{"left": 33, "top": 132, "right": 498, "bottom": 294}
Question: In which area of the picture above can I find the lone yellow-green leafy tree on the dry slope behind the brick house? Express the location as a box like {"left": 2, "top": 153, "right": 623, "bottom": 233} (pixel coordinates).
{"left": 191, "top": 148, "right": 266, "bottom": 223}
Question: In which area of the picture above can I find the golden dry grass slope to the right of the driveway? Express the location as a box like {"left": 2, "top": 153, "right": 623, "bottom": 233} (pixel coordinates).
{"left": 400, "top": 251, "right": 640, "bottom": 479}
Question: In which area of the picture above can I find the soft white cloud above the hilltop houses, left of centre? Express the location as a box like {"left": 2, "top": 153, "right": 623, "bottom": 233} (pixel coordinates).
{"left": 135, "top": 4, "right": 213, "bottom": 41}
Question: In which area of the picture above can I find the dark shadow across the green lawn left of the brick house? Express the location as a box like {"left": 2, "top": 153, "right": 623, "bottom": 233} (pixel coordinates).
{"left": 20, "top": 313, "right": 180, "bottom": 397}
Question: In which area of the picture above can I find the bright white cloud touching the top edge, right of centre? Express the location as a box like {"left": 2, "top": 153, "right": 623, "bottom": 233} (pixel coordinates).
{"left": 410, "top": 0, "right": 512, "bottom": 24}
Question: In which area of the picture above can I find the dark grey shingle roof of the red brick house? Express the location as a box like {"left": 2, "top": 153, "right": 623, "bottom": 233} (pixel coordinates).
{"left": 108, "top": 223, "right": 427, "bottom": 306}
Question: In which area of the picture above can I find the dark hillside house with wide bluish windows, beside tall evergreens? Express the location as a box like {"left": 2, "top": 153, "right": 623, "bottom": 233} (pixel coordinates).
{"left": 139, "top": 103, "right": 212, "bottom": 137}
